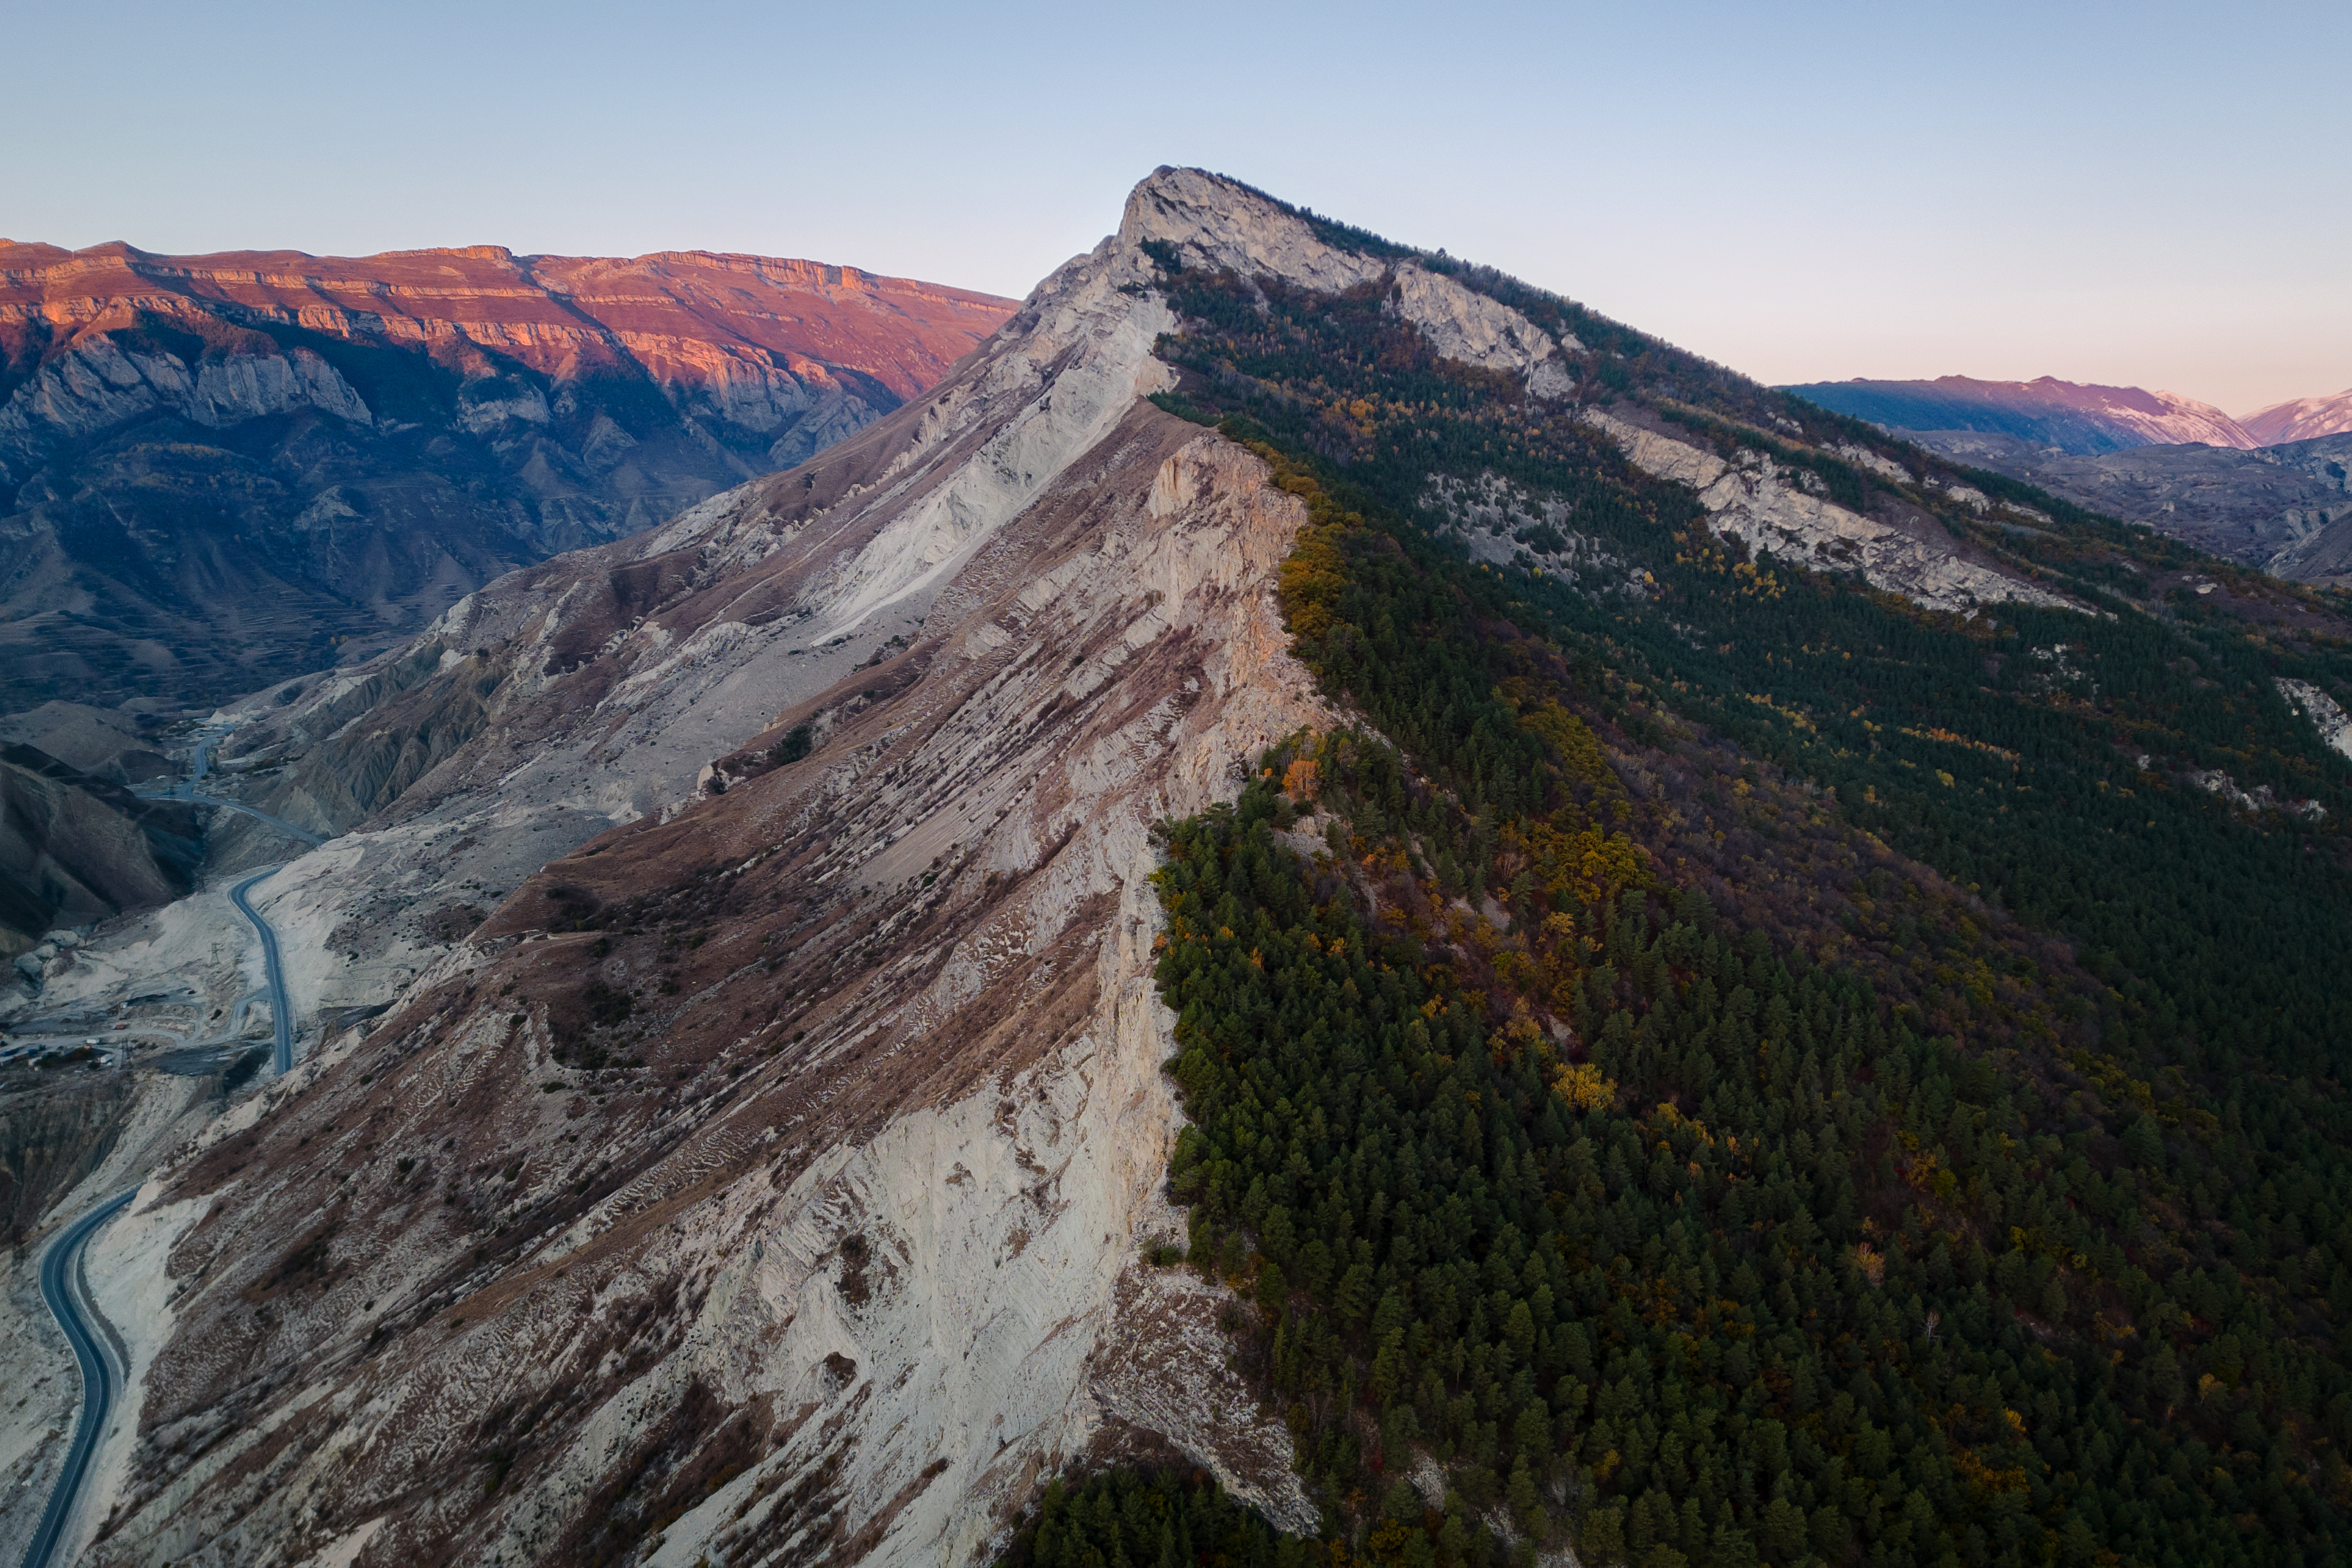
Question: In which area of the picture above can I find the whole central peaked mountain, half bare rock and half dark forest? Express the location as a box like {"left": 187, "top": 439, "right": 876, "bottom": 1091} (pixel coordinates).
{"left": 0, "top": 169, "right": 2352, "bottom": 1568}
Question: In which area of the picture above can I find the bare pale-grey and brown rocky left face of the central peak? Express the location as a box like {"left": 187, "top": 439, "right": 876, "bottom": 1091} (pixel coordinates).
{"left": 4, "top": 169, "right": 2098, "bottom": 1568}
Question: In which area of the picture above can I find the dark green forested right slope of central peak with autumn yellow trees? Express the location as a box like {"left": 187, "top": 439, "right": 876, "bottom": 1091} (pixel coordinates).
{"left": 1014, "top": 187, "right": 2352, "bottom": 1568}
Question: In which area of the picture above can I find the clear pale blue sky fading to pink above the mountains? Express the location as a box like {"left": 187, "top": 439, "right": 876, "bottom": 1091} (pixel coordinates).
{"left": 0, "top": 0, "right": 2352, "bottom": 413}
